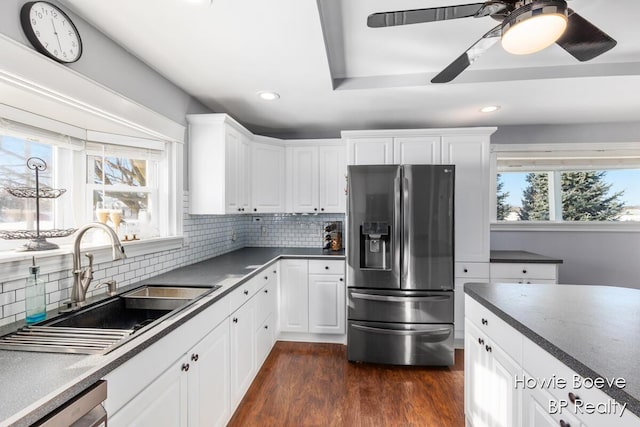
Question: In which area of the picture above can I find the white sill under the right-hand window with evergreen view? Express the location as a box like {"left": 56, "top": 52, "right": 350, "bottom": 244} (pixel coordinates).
{"left": 491, "top": 221, "right": 640, "bottom": 233}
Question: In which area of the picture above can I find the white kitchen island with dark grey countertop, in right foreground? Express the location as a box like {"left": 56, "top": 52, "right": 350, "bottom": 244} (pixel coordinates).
{"left": 465, "top": 283, "right": 640, "bottom": 426}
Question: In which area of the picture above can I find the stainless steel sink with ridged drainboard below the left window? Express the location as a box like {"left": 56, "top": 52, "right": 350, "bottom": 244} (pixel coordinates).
{"left": 0, "top": 285, "right": 220, "bottom": 354}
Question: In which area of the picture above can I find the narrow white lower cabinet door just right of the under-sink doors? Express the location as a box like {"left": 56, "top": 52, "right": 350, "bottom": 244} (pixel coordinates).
{"left": 230, "top": 299, "right": 255, "bottom": 407}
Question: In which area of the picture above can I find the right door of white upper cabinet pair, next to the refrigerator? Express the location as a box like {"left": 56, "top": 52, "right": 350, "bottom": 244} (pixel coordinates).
{"left": 319, "top": 146, "right": 347, "bottom": 214}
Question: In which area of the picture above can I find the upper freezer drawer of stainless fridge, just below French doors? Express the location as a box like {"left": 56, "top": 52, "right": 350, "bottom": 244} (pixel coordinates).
{"left": 349, "top": 288, "right": 454, "bottom": 323}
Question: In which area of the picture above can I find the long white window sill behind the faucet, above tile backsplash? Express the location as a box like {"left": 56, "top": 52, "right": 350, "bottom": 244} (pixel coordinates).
{"left": 0, "top": 236, "right": 184, "bottom": 282}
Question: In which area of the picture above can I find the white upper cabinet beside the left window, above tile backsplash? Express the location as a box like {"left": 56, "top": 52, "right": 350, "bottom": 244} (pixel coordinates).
{"left": 187, "top": 114, "right": 251, "bottom": 215}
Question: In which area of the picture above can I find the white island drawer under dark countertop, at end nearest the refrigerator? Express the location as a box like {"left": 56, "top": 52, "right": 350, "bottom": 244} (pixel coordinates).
{"left": 464, "top": 295, "right": 523, "bottom": 364}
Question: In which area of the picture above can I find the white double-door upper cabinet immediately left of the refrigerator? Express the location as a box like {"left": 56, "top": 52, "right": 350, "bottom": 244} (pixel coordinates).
{"left": 287, "top": 141, "right": 347, "bottom": 213}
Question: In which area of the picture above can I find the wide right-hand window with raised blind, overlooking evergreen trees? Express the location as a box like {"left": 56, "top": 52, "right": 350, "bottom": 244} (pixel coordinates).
{"left": 494, "top": 144, "right": 640, "bottom": 223}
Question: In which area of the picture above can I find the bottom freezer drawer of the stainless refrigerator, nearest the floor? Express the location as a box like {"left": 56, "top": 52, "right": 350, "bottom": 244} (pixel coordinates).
{"left": 347, "top": 321, "right": 454, "bottom": 366}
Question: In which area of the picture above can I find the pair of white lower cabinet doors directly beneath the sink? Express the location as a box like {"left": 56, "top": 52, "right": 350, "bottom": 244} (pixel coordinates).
{"left": 109, "top": 320, "right": 230, "bottom": 427}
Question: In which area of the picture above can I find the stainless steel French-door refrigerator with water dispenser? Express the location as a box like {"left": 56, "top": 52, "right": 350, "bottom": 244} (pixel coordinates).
{"left": 347, "top": 165, "right": 455, "bottom": 366}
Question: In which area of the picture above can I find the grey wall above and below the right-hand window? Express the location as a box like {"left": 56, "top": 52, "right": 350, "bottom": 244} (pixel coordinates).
{"left": 491, "top": 122, "right": 640, "bottom": 288}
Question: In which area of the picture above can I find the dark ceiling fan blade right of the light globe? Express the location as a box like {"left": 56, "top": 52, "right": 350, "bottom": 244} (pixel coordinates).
{"left": 556, "top": 9, "right": 618, "bottom": 62}
